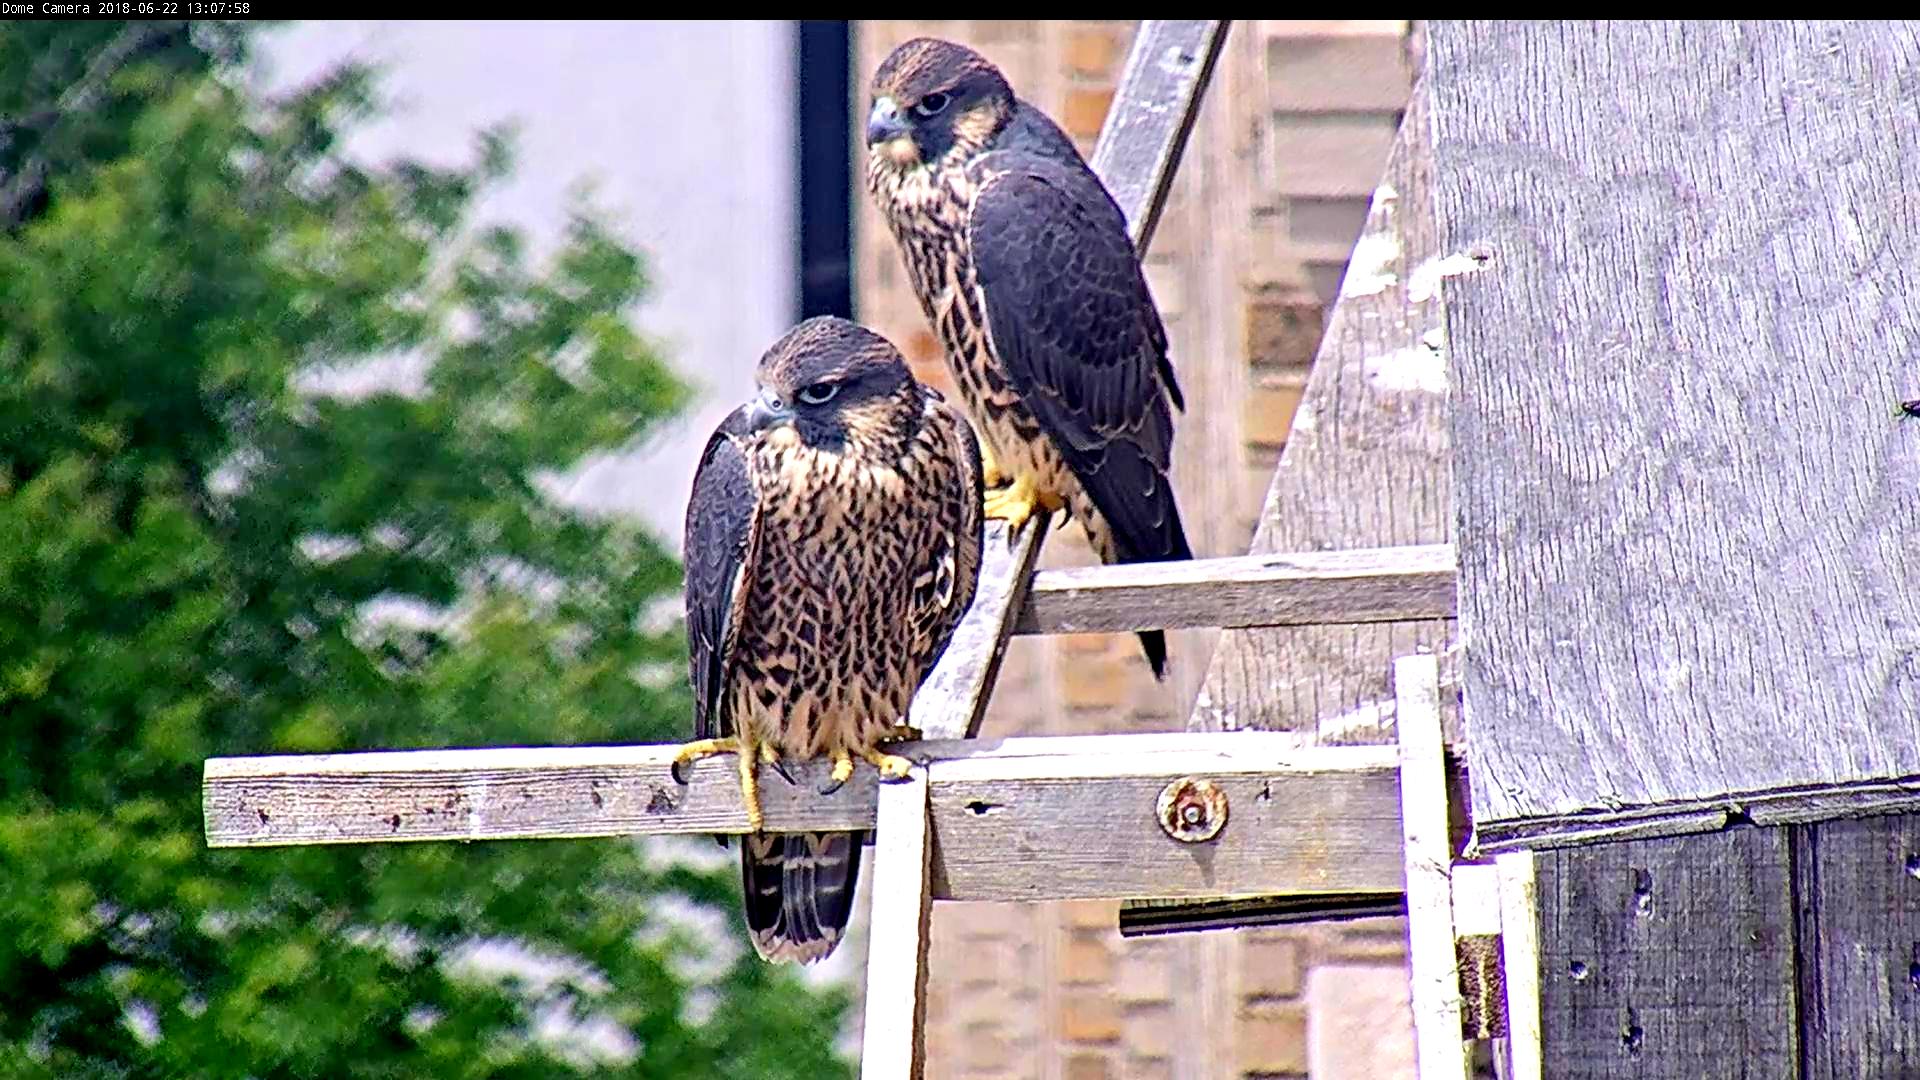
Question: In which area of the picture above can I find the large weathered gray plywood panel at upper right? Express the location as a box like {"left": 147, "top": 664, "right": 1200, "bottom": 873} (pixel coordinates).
{"left": 1428, "top": 21, "right": 1920, "bottom": 849}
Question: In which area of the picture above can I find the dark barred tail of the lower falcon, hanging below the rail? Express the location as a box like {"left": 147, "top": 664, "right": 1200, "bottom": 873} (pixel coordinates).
{"left": 739, "top": 832, "right": 864, "bottom": 963}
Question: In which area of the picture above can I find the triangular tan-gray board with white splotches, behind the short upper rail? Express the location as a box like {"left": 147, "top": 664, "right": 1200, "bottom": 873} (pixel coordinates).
{"left": 1192, "top": 88, "right": 1457, "bottom": 742}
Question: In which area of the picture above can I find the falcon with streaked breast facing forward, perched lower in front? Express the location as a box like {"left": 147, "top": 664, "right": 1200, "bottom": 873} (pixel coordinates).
{"left": 674, "top": 319, "right": 981, "bottom": 963}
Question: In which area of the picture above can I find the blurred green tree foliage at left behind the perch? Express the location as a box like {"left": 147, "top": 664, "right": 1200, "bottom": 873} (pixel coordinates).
{"left": 0, "top": 23, "right": 847, "bottom": 1080}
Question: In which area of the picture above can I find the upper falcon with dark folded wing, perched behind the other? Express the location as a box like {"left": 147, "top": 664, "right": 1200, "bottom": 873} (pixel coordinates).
{"left": 866, "top": 38, "right": 1192, "bottom": 678}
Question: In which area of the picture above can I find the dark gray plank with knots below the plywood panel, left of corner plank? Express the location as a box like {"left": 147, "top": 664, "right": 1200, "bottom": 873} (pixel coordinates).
{"left": 1536, "top": 828, "right": 1799, "bottom": 1080}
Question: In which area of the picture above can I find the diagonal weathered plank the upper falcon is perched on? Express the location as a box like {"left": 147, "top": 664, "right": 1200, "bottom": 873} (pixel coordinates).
{"left": 912, "top": 19, "right": 1227, "bottom": 738}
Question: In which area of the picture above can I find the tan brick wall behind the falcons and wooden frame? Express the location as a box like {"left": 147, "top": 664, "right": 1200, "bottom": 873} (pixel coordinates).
{"left": 843, "top": 21, "right": 1411, "bottom": 1080}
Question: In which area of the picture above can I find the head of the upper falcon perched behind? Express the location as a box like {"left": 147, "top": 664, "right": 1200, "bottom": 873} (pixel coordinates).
{"left": 866, "top": 38, "right": 1014, "bottom": 171}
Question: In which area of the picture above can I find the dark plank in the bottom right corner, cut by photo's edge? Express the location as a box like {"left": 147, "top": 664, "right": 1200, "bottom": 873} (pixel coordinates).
{"left": 1793, "top": 815, "right": 1920, "bottom": 1080}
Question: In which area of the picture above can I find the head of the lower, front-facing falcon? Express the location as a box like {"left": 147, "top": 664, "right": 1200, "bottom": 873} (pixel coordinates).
{"left": 743, "top": 315, "right": 920, "bottom": 454}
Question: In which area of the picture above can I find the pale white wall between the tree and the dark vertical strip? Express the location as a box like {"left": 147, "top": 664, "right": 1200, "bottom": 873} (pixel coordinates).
{"left": 261, "top": 21, "right": 799, "bottom": 552}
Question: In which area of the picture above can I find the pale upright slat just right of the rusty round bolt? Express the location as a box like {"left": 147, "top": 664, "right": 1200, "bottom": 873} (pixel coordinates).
{"left": 1394, "top": 655, "right": 1467, "bottom": 1080}
